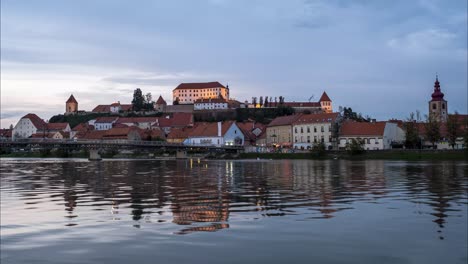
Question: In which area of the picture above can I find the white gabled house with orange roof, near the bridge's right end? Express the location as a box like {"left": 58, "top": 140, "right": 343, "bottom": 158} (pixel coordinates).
{"left": 184, "top": 121, "right": 245, "bottom": 146}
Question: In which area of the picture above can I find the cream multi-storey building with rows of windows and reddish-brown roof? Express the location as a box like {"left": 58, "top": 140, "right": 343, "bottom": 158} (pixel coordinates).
{"left": 292, "top": 113, "right": 339, "bottom": 149}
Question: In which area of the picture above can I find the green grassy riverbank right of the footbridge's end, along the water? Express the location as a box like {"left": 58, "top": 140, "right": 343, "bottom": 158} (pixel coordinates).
{"left": 239, "top": 150, "right": 468, "bottom": 161}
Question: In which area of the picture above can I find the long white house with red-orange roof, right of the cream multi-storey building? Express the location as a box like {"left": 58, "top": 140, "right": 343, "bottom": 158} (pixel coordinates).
{"left": 338, "top": 121, "right": 404, "bottom": 150}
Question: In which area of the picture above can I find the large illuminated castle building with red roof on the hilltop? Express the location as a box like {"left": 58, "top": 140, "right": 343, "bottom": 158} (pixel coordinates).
{"left": 172, "top": 82, "right": 229, "bottom": 104}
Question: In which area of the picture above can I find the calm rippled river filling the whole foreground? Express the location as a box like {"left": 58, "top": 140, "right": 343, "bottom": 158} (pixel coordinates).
{"left": 0, "top": 159, "right": 468, "bottom": 263}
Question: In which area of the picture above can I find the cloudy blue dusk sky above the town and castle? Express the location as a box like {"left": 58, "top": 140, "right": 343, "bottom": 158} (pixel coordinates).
{"left": 0, "top": 0, "right": 468, "bottom": 128}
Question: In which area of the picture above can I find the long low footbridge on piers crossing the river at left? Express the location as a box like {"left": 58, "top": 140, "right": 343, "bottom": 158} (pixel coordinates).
{"left": 0, "top": 138, "right": 244, "bottom": 159}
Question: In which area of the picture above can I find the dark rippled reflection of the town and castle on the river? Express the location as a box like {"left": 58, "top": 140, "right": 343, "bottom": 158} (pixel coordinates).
{"left": 1, "top": 159, "right": 468, "bottom": 236}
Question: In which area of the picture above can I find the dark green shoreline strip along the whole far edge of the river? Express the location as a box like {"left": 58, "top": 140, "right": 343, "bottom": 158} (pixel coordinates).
{"left": 0, "top": 150, "right": 468, "bottom": 161}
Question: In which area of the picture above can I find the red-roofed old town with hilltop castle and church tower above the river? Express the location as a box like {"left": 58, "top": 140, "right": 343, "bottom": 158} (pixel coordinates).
{"left": 0, "top": 77, "right": 468, "bottom": 152}
